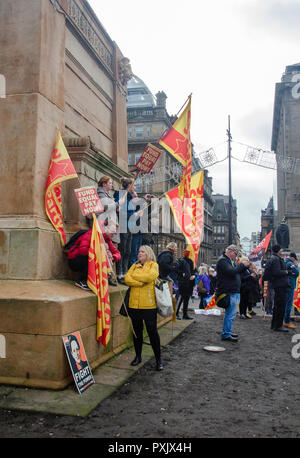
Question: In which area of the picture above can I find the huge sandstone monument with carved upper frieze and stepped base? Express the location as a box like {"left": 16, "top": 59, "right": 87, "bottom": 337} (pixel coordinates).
{"left": 0, "top": 0, "right": 159, "bottom": 389}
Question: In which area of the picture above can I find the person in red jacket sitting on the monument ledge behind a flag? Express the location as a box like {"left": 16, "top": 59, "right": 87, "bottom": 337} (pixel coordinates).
{"left": 67, "top": 225, "right": 121, "bottom": 290}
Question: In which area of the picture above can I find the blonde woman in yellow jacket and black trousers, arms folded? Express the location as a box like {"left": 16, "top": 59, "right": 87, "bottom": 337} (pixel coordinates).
{"left": 124, "top": 245, "right": 163, "bottom": 371}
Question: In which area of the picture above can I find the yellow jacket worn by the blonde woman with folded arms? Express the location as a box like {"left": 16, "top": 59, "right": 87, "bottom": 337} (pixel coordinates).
{"left": 124, "top": 261, "right": 159, "bottom": 309}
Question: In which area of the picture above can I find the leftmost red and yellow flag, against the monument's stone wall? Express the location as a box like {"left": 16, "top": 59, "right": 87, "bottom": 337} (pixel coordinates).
{"left": 45, "top": 132, "right": 78, "bottom": 246}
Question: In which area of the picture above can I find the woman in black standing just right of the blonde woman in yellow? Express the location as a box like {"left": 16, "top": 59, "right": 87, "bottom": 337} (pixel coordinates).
{"left": 176, "top": 250, "right": 197, "bottom": 320}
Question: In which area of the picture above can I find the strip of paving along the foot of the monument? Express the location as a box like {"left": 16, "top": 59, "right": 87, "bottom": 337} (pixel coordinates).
{"left": 0, "top": 320, "right": 193, "bottom": 417}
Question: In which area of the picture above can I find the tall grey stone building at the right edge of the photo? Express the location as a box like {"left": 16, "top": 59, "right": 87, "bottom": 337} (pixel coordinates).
{"left": 271, "top": 63, "right": 300, "bottom": 252}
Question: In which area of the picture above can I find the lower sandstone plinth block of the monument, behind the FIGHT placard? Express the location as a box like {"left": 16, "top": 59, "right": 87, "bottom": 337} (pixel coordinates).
{"left": 0, "top": 280, "right": 170, "bottom": 390}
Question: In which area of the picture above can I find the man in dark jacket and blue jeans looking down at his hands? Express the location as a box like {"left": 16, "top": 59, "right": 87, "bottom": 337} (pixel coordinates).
{"left": 216, "top": 245, "right": 250, "bottom": 342}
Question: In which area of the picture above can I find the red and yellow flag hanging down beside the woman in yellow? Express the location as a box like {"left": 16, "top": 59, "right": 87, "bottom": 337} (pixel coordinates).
{"left": 87, "top": 213, "right": 111, "bottom": 347}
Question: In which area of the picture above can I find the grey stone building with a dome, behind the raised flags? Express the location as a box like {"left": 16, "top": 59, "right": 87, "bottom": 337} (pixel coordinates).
{"left": 127, "top": 75, "right": 213, "bottom": 263}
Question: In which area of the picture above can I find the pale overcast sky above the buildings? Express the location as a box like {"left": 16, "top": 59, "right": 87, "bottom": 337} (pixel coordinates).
{"left": 89, "top": 0, "right": 300, "bottom": 242}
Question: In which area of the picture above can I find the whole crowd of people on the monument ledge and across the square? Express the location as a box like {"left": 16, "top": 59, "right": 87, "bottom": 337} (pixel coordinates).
{"left": 65, "top": 176, "right": 299, "bottom": 370}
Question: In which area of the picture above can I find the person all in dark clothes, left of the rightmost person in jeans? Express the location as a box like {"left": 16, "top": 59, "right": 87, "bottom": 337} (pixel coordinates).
{"left": 270, "top": 245, "right": 289, "bottom": 332}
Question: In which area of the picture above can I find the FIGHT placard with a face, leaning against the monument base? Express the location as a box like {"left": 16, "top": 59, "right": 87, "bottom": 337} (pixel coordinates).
{"left": 62, "top": 331, "right": 95, "bottom": 394}
